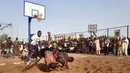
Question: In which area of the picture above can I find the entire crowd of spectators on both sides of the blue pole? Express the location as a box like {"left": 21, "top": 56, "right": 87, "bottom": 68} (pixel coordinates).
{"left": 0, "top": 37, "right": 130, "bottom": 56}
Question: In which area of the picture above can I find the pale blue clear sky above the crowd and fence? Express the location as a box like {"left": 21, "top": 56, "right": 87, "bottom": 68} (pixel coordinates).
{"left": 0, "top": 0, "right": 130, "bottom": 38}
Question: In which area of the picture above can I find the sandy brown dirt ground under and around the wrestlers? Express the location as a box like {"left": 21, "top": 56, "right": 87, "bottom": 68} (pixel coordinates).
{"left": 0, "top": 54, "right": 130, "bottom": 73}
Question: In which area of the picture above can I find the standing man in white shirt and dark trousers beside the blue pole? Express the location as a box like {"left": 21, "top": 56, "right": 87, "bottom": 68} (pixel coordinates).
{"left": 27, "top": 31, "right": 42, "bottom": 63}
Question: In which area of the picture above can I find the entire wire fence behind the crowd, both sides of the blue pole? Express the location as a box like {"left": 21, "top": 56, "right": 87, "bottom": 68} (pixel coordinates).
{"left": 0, "top": 25, "right": 130, "bottom": 42}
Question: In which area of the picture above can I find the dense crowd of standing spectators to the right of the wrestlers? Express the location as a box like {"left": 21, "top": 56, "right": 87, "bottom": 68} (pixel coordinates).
{"left": 51, "top": 37, "right": 130, "bottom": 56}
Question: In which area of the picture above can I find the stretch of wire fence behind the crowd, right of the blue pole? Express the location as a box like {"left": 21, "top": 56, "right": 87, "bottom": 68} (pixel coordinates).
{"left": 43, "top": 25, "right": 130, "bottom": 40}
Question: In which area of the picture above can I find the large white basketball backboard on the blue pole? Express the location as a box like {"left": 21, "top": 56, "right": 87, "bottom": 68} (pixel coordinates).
{"left": 24, "top": 1, "right": 45, "bottom": 20}
